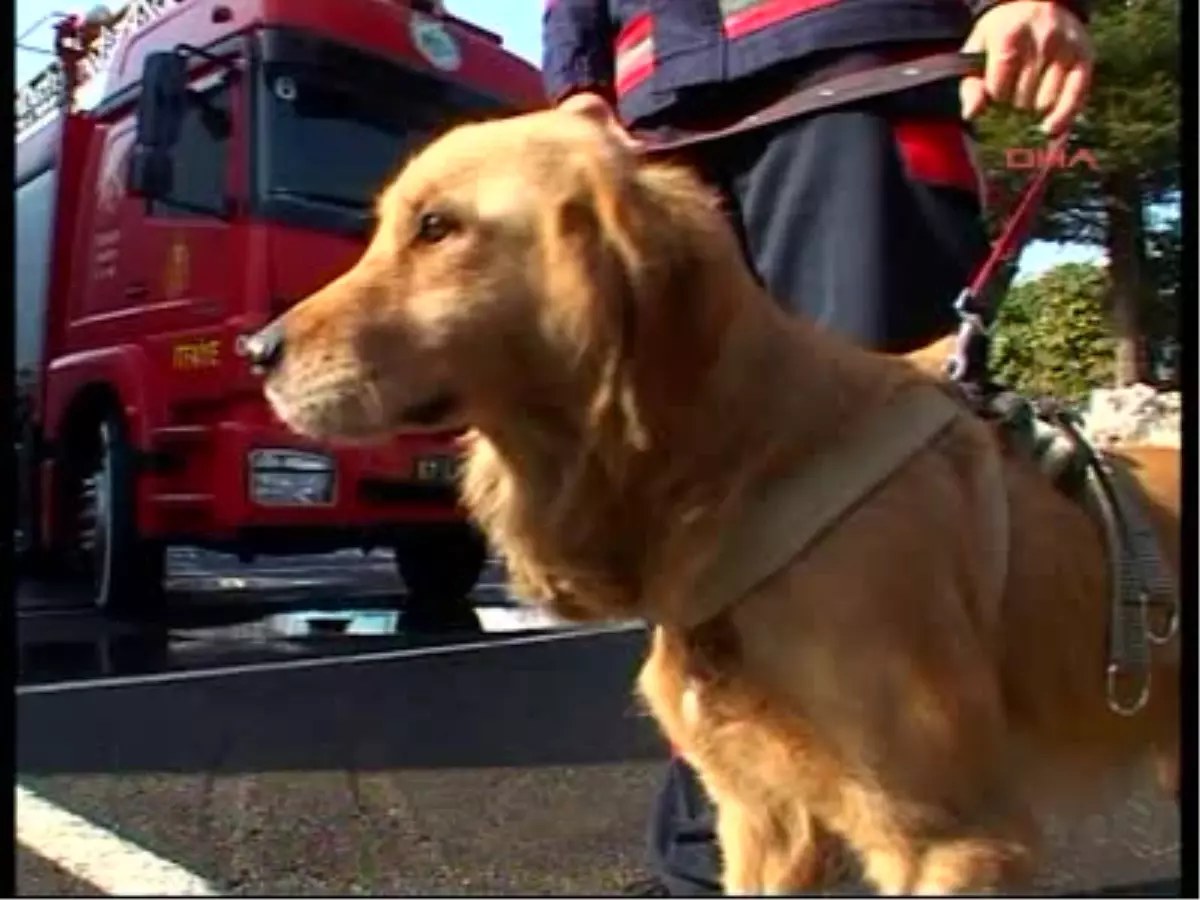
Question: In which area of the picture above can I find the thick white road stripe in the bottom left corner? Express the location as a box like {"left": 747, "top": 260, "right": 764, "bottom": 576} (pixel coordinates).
{"left": 16, "top": 785, "right": 221, "bottom": 896}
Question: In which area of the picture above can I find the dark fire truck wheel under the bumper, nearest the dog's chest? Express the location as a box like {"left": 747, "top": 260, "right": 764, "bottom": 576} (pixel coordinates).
{"left": 394, "top": 522, "right": 487, "bottom": 630}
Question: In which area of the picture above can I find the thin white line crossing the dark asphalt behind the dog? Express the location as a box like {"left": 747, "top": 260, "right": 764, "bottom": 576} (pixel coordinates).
{"left": 13, "top": 622, "right": 646, "bottom": 697}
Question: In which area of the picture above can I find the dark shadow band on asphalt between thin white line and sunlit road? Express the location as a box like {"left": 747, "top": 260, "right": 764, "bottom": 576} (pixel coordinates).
{"left": 17, "top": 630, "right": 665, "bottom": 775}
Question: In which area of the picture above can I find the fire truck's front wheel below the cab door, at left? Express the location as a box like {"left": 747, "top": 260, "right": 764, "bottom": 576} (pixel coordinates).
{"left": 78, "top": 414, "right": 167, "bottom": 617}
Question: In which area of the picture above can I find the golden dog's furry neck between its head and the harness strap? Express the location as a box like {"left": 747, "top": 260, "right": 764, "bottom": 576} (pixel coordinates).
{"left": 463, "top": 277, "right": 904, "bottom": 622}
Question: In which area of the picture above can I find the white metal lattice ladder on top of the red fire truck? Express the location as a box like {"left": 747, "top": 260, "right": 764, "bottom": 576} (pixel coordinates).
{"left": 16, "top": 0, "right": 187, "bottom": 140}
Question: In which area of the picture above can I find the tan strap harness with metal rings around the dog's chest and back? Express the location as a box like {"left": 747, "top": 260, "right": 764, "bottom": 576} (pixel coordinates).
{"left": 672, "top": 384, "right": 1180, "bottom": 716}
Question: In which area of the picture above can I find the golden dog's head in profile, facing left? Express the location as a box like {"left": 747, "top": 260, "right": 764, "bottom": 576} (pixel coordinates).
{"left": 252, "top": 98, "right": 738, "bottom": 444}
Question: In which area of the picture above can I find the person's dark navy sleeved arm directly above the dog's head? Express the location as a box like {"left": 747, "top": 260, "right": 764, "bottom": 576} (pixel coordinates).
{"left": 541, "top": 0, "right": 616, "bottom": 104}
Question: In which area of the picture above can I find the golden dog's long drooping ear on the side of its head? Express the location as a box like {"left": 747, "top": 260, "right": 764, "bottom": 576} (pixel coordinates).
{"left": 545, "top": 159, "right": 660, "bottom": 450}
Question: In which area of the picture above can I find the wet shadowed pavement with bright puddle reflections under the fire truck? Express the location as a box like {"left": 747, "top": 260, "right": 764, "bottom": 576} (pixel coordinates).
{"left": 17, "top": 549, "right": 520, "bottom": 685}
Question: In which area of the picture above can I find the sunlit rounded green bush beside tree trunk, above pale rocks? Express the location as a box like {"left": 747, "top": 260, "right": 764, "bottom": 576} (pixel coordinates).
{"left": 991, "top": 263, "right": 1115, "bottom": 401}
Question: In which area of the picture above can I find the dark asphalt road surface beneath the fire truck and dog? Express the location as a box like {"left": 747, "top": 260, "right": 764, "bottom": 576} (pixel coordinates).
{"left": 17, "top": 554, "right": 1180, "bottom": 895}
